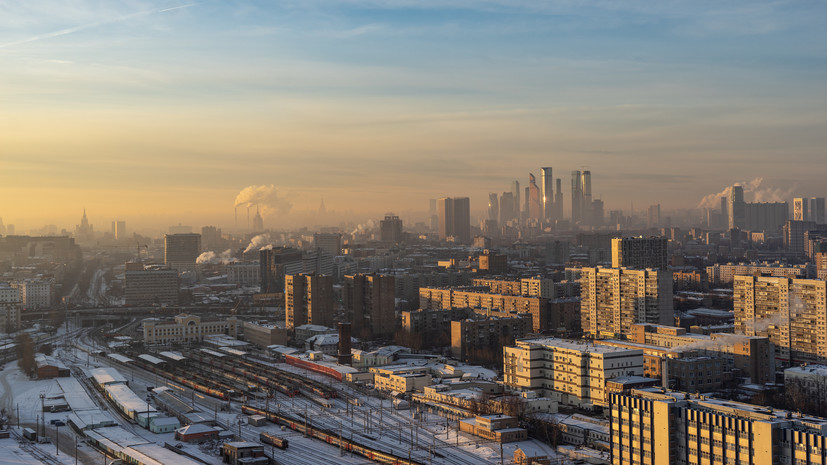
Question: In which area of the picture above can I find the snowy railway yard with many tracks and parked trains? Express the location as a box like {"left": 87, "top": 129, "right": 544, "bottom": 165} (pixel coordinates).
{"left": 0, "top": 322, "right": 568, "bottom": 465}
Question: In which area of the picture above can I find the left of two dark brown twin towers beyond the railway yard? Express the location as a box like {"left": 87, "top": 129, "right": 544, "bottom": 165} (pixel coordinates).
{"left": 284, "top": 273, "right": 333, "bottom": 330}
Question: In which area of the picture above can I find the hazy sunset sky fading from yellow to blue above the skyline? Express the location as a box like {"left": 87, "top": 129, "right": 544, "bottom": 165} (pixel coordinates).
{"left": 0, "top": 0, "right": 827, "bottom": 229}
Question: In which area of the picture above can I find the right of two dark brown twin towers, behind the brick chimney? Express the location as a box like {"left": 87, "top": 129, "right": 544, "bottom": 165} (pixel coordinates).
{"left": 342, "top": 274, "right": 396, "bottom": 339}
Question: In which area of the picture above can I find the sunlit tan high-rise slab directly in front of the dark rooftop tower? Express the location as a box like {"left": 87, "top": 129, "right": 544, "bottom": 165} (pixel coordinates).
{"left": 580, "top": 267, "right": 674, "bottom": 337}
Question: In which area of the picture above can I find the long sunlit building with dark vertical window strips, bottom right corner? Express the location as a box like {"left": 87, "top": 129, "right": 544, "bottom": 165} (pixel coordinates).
{"left": 609, "top": 388, "right": 827, "bottom": 465}
